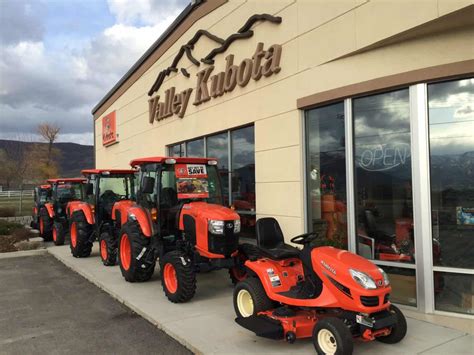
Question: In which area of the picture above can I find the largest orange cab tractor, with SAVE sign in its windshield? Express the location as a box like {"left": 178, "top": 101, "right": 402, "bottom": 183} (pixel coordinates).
{"left": 118, "top": 157, "right": 245, "bottom": 303}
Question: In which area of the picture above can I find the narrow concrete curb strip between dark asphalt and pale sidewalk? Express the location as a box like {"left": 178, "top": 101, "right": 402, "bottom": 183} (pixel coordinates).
{"left": 44, "top": 249, "right": 204, "bottom": 354}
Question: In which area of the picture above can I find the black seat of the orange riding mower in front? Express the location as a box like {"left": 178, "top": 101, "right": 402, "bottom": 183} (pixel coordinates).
{"left": 256, "top": 217, "right": 300, "bottom": 260}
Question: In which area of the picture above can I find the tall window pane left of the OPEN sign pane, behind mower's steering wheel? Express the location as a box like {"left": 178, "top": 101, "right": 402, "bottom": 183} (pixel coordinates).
{"left": 306, "top": 102, "right": 347, "bottom": 249}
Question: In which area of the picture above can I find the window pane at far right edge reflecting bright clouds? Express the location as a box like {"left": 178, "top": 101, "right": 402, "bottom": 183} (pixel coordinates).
{"left": 428, "top": 79, "right": 474, "bottom": 268}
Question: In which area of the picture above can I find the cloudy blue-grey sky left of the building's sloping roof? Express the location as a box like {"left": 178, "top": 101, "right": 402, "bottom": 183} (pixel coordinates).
{"left": 0, "top": 0, "right": 190, "bottom": 144}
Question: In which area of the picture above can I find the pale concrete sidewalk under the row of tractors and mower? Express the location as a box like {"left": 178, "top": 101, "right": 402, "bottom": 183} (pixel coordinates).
{"left": 48, "top": 244, "right": 474, "bottom": 354}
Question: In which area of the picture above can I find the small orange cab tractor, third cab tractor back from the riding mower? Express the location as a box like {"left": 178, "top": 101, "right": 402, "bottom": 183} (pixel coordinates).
{"left": 39, "top": 178, "right": 86, "bottom": 245}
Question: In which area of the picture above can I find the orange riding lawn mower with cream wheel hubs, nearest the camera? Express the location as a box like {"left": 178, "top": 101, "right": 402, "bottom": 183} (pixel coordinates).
{"left": 233, "top": 218, "right": 407, "bottom": 355}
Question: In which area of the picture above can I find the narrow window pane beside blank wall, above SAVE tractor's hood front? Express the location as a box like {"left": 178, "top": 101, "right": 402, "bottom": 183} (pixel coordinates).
{"left": 231, "top": 126, "right": 256, "bottom": 236}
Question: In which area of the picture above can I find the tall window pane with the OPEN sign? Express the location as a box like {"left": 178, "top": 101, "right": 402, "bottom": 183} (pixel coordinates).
{"left": 353, "top": 89, "right": 415, "bottom": 263}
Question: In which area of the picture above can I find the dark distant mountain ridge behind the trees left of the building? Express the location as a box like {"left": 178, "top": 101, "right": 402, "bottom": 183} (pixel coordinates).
{"left": 0, "top": 139, "right": 94, "bottom": 177}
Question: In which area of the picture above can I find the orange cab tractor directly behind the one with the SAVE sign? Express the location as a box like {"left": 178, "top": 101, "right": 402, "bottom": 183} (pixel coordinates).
{"left": 68, "top": 169, "right": 136, "bottom": 266}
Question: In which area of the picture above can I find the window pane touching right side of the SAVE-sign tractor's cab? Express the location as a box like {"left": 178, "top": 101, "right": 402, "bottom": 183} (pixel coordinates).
{"left": 206, "top": 132, "right": 229, "bottom": 204}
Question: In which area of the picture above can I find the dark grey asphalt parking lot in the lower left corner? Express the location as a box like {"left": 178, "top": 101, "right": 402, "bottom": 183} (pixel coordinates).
{"left": 0, "top": 254, "right": 190, "bottom": 354}
